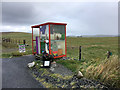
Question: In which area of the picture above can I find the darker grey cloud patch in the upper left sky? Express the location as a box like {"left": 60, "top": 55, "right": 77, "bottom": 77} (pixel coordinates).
{"left": 2, "top": 2, "right": 35, "bottom": 25}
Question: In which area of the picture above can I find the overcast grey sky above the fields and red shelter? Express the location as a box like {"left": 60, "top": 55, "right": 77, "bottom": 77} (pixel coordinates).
{"left": 2, "top": 2, "right": 118, "bottom": 35}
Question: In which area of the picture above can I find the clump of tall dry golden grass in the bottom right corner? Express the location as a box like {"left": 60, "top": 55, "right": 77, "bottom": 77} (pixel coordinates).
{"left": 85, "top": 56, "right": 120, "bottom": 88}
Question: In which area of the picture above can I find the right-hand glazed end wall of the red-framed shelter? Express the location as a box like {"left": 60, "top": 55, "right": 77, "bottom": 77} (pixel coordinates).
{"left": 50, "top": 25, "right": 65, "bottom": 56}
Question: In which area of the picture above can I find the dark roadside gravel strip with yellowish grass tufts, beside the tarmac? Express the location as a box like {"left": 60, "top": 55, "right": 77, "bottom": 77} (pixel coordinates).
{"left": 31, "top": 64, "right": 109, "bottom": 89}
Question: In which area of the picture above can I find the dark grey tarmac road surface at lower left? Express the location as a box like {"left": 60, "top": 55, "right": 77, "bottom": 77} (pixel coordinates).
{"left": 2, "top": 55, "right": 44, "bottom": 88}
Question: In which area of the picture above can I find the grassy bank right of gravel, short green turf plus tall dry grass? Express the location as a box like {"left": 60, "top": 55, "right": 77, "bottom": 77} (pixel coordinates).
{"left": 57, "top": 55, "right": 120, "bottom": 88}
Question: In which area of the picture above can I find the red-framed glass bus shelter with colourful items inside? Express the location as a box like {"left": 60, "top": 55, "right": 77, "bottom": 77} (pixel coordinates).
{"left": 32, "top": 22, "right": 67, "bottom": 58}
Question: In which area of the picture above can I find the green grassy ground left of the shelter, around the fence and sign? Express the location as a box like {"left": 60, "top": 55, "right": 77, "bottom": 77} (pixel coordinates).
{"left": 2, "top": 32, "right": 32, "bottom": 58}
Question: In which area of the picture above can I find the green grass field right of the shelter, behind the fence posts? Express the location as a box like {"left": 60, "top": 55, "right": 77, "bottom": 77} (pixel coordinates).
{"left": 67, "top": 37, "right": 118, "bottom": 60}
